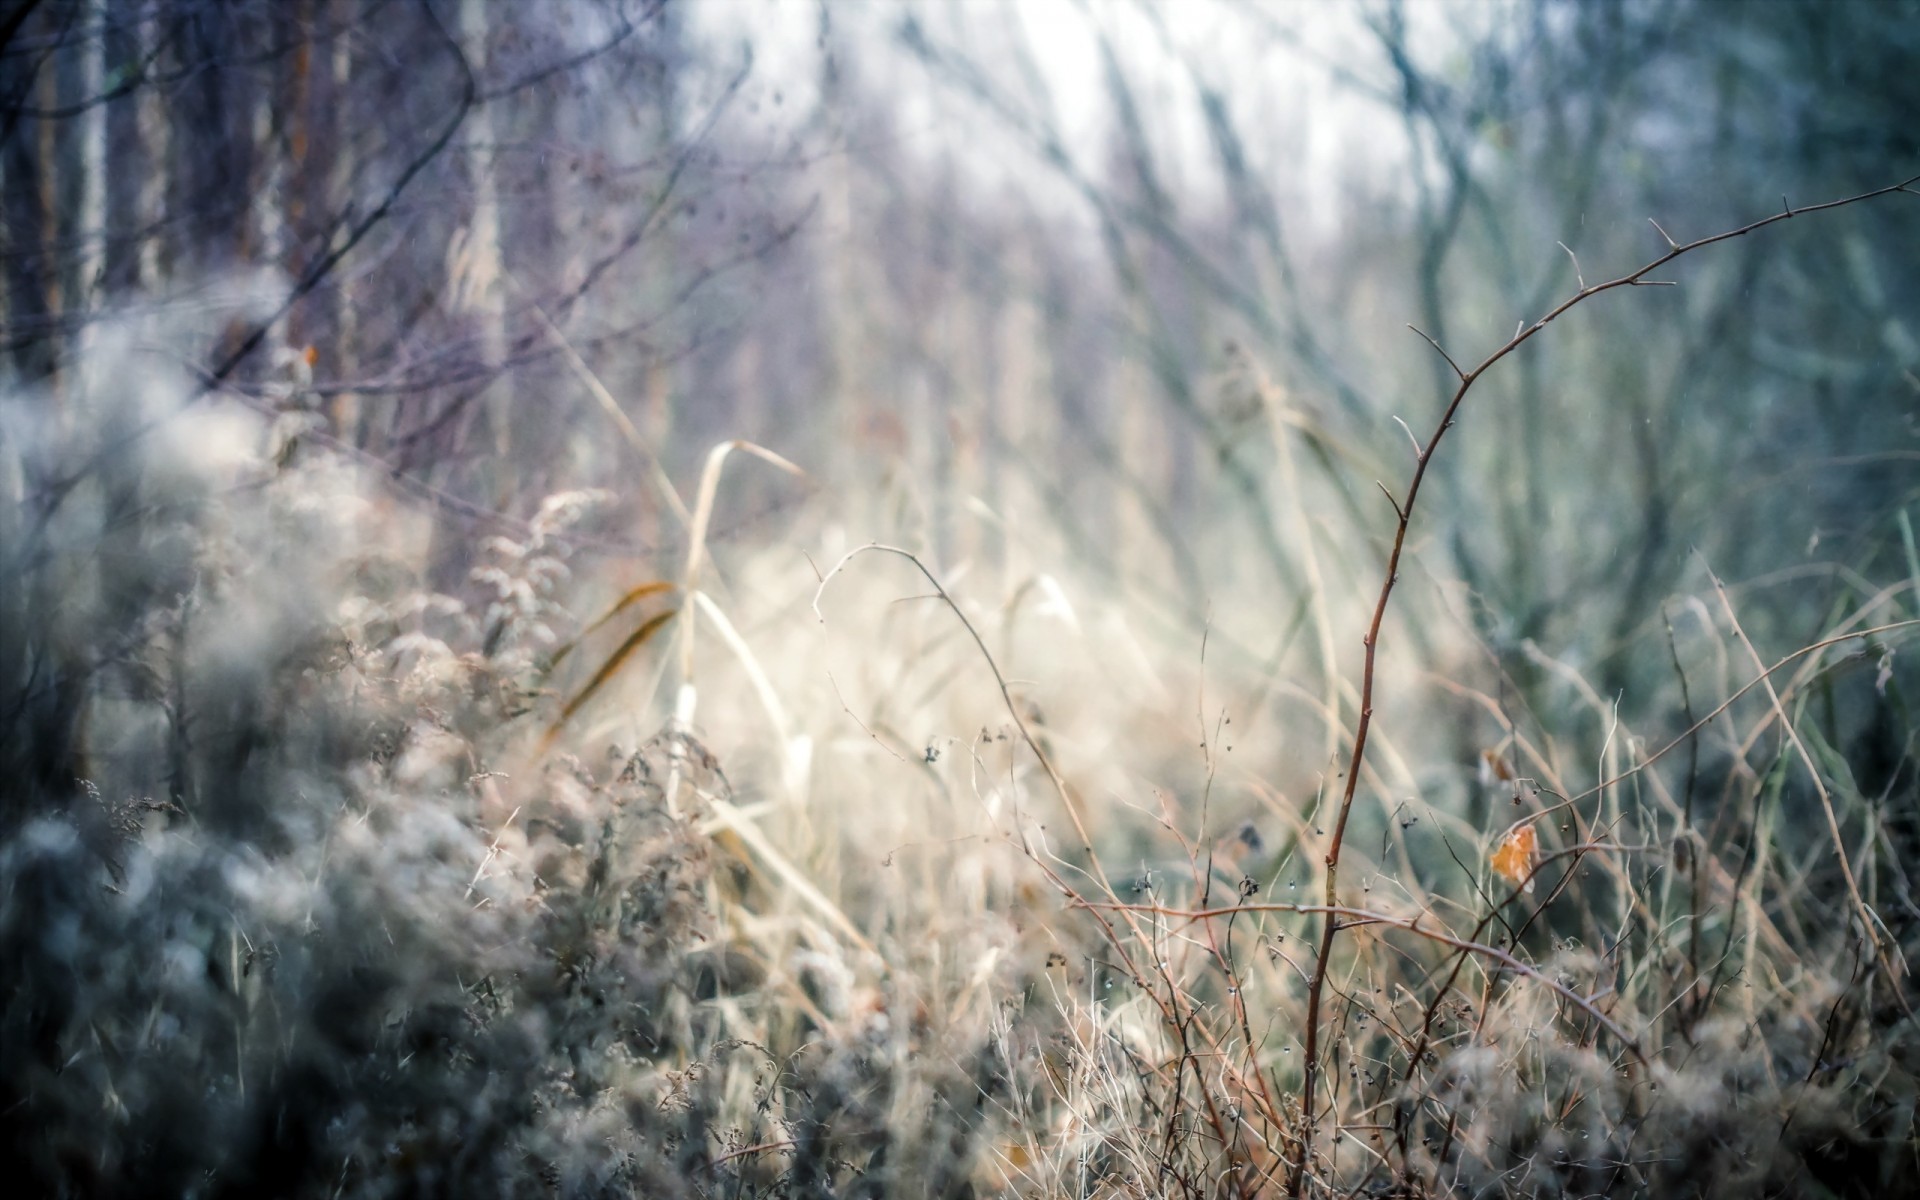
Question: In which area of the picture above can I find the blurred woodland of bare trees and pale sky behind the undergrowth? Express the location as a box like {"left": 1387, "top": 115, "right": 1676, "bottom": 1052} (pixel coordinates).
{"left": 4, "top": 0, "right": 1920, "bottom": 703}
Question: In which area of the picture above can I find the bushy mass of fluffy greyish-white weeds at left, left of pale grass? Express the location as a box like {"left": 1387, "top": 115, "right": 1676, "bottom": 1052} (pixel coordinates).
{"left": 0, "top": 339, "right": 1013, "bottom": 1196}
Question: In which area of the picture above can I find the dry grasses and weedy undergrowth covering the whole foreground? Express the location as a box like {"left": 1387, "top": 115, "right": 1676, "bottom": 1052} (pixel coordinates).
{"left": 0, "top": 189, "right": 1920, "bottom": 1196}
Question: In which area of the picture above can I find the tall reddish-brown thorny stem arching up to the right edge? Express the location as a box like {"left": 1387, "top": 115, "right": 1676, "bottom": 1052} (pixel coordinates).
{"left": 1288, "top": 175, "right": 1920, "bottom": 1196}
